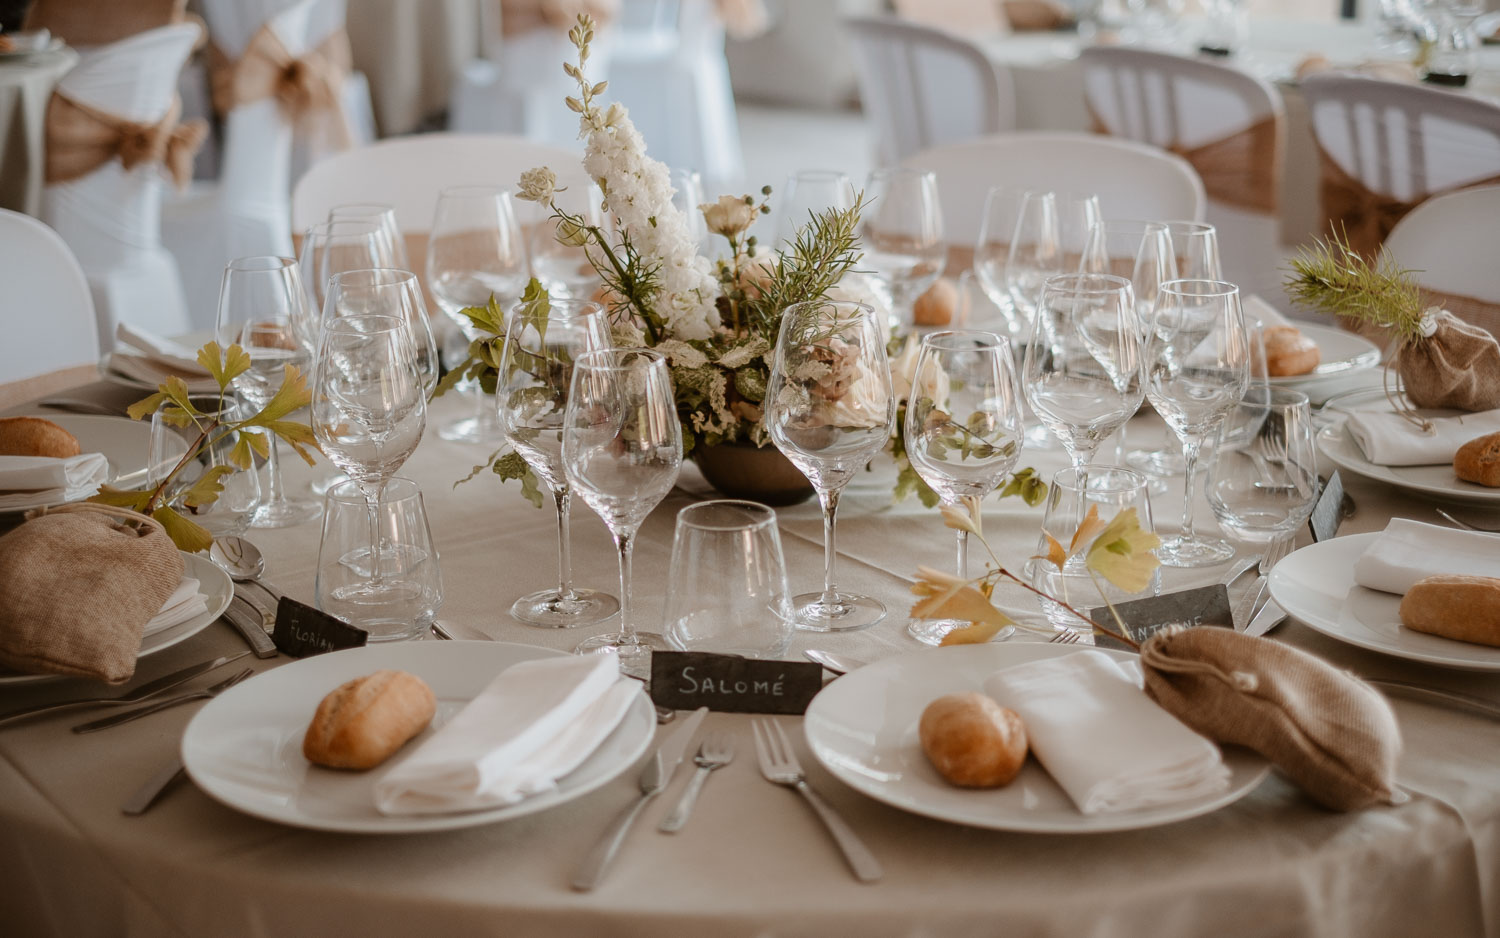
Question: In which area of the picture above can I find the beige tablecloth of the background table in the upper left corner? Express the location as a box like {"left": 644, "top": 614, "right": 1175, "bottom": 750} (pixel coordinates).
{"left": 0, "top": 48, "right": 78, "bottom": 215}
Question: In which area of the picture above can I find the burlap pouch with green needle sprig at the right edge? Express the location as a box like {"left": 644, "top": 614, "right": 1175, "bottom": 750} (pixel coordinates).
{"left": 1394, "top": 308, "right": 1500, "bottom": 411}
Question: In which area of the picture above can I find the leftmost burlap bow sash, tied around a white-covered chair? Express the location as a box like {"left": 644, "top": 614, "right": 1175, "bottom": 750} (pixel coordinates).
{"left": 47, "top": 92, "right": 209, "bottom": 189}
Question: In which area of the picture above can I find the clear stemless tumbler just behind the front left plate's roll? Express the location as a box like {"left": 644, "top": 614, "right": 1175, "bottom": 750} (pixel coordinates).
{"left": 315, "top": 476, "right": 443, "bottom": 642}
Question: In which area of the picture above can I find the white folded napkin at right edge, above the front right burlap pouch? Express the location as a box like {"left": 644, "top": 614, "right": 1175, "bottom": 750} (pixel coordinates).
{"left": 1355, "top": 518, "right": 1500, "bottom": 596}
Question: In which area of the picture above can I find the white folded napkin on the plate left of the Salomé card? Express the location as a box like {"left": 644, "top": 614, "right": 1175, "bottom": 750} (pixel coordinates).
{"left": 375, "top": 654, "right": 641, "bottom": 815}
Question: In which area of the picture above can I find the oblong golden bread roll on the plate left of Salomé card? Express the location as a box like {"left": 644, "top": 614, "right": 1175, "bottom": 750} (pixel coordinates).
{"left": 302, "top": 671, "right": 438, "bottom": 770}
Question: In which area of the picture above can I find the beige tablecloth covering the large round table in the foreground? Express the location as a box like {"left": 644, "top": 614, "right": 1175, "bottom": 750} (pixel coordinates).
{"left": 0, "top": 376, "right": 1500, "bottom": 938}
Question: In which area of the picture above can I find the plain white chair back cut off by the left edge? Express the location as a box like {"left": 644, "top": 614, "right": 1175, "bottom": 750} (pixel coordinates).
{"left": 0, "top": 209, "right": 99, "bottom": 387}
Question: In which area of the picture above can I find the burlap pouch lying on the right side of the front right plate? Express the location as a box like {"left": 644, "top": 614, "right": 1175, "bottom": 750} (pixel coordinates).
{"left": 1140, "top": 629, "right": 1407, "bottom": 810}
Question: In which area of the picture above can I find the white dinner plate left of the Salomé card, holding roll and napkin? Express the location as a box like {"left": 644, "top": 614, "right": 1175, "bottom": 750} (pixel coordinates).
{"left": 183, "top": 641, "right": 656, "bottom": 834}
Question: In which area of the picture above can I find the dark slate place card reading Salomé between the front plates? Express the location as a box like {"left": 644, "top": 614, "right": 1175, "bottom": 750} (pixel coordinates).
{"left": 651, "top": 651, "right": 824, "bottom": 713}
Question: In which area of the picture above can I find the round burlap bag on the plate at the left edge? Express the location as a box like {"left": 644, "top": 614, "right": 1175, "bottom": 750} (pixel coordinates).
{"left": 0, "top": 501, "right": 183, "bottom": 684}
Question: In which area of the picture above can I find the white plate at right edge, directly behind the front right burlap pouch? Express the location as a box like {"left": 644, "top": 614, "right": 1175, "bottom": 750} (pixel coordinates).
{"left": 1268, "top": 531, "right": 1500, "bottom": 671}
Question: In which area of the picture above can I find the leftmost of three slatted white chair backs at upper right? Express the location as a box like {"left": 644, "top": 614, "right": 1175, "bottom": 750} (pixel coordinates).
{"left": 845, "top": 17, "right": 1016, "bottom": 165}
